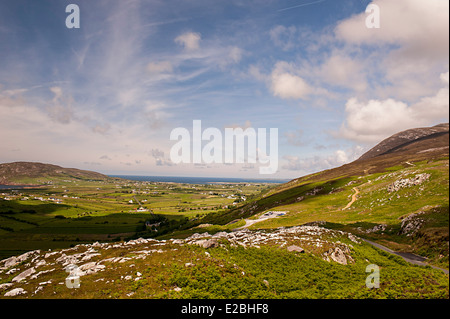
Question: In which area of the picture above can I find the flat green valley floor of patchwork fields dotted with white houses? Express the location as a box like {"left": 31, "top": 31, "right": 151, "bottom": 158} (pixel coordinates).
{"left": 0, "top": 178, "right": 269, "bottom": 258}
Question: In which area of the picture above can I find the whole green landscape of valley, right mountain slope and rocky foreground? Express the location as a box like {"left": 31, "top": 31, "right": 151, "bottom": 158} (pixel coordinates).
{"left": 0, "top": 125, "right": 449, "bottom": 299}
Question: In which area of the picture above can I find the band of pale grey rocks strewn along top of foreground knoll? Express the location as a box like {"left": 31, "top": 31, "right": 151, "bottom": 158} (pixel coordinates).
{"left": 0, "top": 225, "right": 361, "bottom": 297}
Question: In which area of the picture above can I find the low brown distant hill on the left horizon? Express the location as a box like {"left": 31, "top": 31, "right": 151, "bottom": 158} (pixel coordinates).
{"left": 0, "top": 162, "right": 109, "bottom": 185}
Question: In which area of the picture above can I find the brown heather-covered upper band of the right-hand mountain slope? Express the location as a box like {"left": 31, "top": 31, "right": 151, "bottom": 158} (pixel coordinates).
{"left": 209, "top": 124, "right": 449, "bottom": 224}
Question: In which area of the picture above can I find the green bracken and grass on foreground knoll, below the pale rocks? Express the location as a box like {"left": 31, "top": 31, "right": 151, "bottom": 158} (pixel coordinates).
{"left": 0, "top": 238, "right": 449, "bottom": 299}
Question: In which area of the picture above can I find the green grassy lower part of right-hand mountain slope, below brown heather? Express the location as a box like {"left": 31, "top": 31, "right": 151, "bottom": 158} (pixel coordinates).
{"left": 199, "top": 158, "right": 449, "bottom": 269}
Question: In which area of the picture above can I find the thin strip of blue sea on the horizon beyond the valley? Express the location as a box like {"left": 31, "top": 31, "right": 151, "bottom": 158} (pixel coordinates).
{"left": 109, "top": 175, "right": 289, "bottom": 184}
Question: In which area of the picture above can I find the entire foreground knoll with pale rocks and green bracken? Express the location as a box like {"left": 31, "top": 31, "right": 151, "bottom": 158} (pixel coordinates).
{"left": 0, "top": 226, "right": 449, "bottom": 299}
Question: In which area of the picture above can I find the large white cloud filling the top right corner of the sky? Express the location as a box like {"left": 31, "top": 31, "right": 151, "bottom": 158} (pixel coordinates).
{"left": 335, "top": 0, "right": 449, "bottom": 57}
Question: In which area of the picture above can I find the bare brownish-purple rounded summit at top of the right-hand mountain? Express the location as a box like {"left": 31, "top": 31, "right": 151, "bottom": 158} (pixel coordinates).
{"left": 359, "top": 123, "right": 449, "bottom": 160}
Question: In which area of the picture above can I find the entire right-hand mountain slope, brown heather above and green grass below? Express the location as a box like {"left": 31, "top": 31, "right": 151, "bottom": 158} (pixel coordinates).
{"left": 201, "top": 124, "right": 449, "bottom": 268}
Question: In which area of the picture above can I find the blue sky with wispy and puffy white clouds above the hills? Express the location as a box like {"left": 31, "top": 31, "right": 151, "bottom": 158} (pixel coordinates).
{"left": 0, "top": 0, "right": 449, "bottom": 179}
